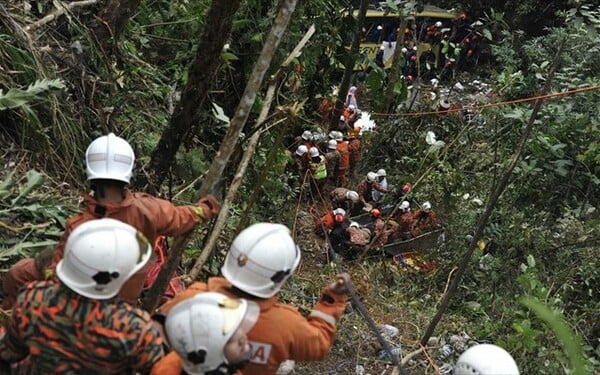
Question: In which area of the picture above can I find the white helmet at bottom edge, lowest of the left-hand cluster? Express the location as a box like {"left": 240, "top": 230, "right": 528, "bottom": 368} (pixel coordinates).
{"left": 164, "top": 292, "right": 260, "bottom": 375}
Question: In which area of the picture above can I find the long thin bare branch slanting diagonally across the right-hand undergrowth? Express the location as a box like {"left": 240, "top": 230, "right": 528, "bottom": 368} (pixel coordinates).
{"left": 421, "top": 39, "right": 565, "bottom": 346}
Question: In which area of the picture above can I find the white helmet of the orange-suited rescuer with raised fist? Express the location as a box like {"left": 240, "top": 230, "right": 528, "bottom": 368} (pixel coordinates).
{"left": 221, "top": 223, "right": 300, "bottom": 298}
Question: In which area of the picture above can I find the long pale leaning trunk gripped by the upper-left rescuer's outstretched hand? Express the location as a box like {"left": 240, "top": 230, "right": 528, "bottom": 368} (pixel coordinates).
{"left": 142, "top": 0, "right": 298, "bottom": 311}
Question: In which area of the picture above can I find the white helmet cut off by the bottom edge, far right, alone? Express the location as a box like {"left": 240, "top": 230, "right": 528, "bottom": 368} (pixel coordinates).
{"left": 454, "top": 344, "right": 519, "bottom": 375}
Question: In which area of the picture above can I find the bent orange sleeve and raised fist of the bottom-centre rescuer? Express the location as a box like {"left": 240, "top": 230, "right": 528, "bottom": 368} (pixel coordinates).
{"left": 286, "top": 288, "right": 346, "bottom": 361}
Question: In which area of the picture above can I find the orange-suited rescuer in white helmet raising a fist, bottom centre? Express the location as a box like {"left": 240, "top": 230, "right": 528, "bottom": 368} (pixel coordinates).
{"left": 159, "top": 223, "right": 350, "bottom": 375}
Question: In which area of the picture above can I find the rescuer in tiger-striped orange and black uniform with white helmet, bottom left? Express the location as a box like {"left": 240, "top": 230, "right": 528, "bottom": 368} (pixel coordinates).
{"left": 0, "top": 218, "right": 164, "bottom": 374}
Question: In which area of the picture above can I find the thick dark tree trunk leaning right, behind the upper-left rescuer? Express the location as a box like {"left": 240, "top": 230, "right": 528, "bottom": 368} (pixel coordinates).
{"left": 141, "top": 0, "right": 245, "bottom": 193}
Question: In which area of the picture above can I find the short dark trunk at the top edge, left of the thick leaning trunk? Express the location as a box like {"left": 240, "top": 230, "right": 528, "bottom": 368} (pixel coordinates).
{"left": 93, "top": 0, "right": 141, "bottom": 56}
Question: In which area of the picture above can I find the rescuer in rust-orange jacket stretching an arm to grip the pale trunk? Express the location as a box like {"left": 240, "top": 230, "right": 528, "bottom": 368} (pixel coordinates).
{"left": 3, "top": 133, "right": 220, "bottom": 308}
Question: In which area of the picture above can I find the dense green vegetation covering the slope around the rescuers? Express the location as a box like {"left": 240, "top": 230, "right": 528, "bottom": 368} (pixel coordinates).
{"left": 0, "top": 0, "right": 600, "bottom": 374}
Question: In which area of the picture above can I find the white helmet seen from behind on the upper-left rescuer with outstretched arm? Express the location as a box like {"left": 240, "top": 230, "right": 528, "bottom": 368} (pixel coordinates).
{"left": 85, "top": 133, "right": 135, "bottom": 183}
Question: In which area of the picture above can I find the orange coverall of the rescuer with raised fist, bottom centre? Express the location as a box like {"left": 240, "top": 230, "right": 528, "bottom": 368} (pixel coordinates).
{"left": 156, "top": 277, "right": 346, "bottom": 375}
